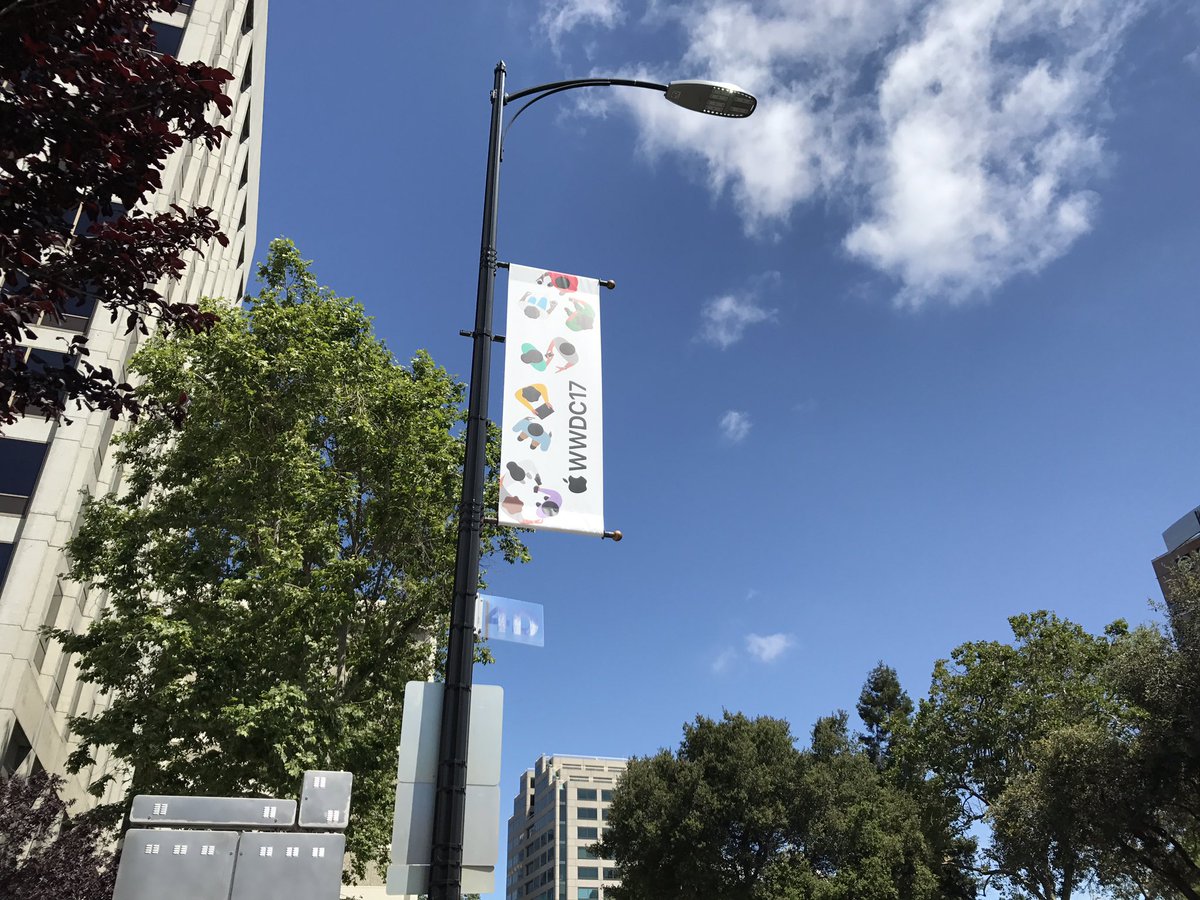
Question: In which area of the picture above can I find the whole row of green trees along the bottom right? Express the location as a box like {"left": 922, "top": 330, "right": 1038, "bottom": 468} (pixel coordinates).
{"left": 609, "top": 580, "right": 1200, "bottom": 900}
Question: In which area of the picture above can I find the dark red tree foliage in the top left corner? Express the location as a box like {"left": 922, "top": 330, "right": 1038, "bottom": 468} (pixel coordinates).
{"left": 0, "top": 0, "right": 232, "bottom": 425}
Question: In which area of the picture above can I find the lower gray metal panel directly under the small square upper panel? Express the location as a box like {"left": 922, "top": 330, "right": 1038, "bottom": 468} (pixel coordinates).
{"left": 229, "top": 832, "right": 346, "bottom": 900}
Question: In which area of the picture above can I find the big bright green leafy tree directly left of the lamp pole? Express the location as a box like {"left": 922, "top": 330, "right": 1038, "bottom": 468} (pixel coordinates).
{"left": 58, "top": 240, "right": 524, "bottom": 866}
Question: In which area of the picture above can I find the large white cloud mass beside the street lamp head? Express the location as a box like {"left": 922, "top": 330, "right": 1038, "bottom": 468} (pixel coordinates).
{"left": 590, "top": 0, "right": 1145, "bottom": 307}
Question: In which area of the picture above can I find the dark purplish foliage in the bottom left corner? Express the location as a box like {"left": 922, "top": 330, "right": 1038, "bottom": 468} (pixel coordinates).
{"left": 0, "top": 772, "right": 116, "bottom": 900}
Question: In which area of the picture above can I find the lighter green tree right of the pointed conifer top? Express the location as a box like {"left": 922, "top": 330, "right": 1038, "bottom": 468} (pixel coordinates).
{"left": 916, "top": 612, "right": 1128, "bottom": 900}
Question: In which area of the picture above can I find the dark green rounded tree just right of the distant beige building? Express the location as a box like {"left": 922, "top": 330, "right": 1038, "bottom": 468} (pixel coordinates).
{"left": 601, "top": 713, "right": 938, "bottom": 900}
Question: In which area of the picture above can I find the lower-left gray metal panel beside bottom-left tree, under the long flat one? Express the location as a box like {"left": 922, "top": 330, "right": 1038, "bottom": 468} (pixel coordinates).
{"left": 113, "top": 828, "right": 238, "bottom": 900}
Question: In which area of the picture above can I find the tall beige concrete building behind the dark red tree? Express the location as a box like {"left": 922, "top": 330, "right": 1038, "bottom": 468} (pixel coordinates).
{"left": 0, "top": 0, "right": 266, "bottom": 810}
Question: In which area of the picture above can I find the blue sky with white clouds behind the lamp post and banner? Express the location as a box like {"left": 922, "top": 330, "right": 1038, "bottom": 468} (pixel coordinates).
{"left": 248, "top": 0, "right": 1200, "bottom": 895}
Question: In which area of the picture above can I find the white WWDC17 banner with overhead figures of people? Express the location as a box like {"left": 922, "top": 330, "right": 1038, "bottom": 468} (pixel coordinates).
{"left": 499, "top": 265, "right": 604, "bottom": 535}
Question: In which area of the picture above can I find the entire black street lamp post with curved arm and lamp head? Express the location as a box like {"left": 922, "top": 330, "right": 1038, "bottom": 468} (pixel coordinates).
{"left": 430, "top": 61, "right": 757, "bottom": 900}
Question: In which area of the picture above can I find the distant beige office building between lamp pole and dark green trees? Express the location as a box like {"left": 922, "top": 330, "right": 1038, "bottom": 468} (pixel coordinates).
{"left": 505, "top": 755, "right": 626, "bottom": 900}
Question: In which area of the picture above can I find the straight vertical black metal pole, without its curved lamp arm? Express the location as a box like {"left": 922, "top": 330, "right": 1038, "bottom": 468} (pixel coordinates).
{"left": 430, "top": 61, "right": 505, "bottom": 900}
